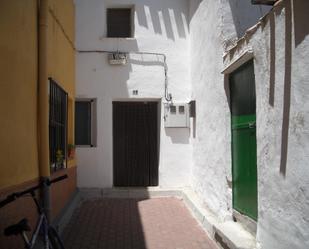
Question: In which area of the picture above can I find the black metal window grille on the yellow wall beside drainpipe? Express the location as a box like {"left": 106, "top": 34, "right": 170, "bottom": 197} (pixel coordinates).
{"left": 49, "top": 78, "right": 68, "bottom": 171}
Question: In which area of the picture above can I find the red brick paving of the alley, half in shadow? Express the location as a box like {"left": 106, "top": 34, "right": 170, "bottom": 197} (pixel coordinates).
{"left": 63, "top": 198, "right": 217, "bottom": 249}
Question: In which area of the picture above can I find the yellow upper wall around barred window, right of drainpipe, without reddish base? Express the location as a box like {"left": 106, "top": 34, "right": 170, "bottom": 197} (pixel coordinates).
{"left": 48, "top": 0, "right": 76, "bottom": 167}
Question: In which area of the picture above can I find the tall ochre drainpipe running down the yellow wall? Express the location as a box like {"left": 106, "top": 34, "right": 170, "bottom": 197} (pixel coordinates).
{"left": 38, "top": 0, "right": 51, "bottom": 220}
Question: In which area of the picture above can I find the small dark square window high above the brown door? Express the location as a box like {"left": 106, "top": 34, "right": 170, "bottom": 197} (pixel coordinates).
{"left": 107, "top": 8, "right": 133, "bottom": 38}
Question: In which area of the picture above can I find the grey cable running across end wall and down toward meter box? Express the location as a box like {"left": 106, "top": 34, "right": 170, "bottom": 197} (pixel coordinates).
{"left": 77, "top": 50, "right": 172, "bottom": 102}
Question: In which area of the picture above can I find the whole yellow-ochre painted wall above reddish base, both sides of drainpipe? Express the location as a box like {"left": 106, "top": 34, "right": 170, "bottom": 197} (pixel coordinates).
{"left": 0, "top": 0, "right": 76, "bottom": 191}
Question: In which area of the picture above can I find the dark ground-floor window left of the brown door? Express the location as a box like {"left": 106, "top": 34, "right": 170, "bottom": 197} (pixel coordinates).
{"left": 75, "top": 99, "right": 96, "bottom": 147}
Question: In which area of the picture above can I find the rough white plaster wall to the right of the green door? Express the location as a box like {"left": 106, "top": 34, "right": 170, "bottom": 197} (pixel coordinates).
{"left": 225, "top": 1, "right": 309, "bottom": 249}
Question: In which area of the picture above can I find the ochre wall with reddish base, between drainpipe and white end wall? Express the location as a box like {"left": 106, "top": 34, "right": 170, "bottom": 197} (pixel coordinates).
{"left": 47, "top": 0, "right": 76, "bottom": 218}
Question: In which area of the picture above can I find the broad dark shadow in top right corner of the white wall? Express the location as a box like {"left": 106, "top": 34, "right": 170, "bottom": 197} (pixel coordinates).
{"left": 293, "top": 0, "right": 309, "bottom": 47}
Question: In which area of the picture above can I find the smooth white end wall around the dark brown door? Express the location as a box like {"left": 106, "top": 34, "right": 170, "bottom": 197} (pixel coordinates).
{"left": 75, "top": 0, "right": 192, "bottom": 187}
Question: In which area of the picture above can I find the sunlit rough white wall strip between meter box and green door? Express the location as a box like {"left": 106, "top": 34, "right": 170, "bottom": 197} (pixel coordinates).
{"left": 190, "top": 1, "right": 231, "bottom": 222}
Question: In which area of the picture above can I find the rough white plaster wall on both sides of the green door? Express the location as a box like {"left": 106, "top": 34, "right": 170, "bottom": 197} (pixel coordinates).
{"left": 190, "top": 0, "right": 309, "bottom": 249}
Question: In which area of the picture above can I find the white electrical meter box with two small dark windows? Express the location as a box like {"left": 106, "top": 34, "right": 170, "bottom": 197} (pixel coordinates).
{"left": 164, "top": 103, "right": 190, "bottom": 128}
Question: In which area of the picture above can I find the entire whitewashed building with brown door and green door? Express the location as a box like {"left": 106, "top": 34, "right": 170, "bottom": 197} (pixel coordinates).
{"left": 75, "top": 0, "right": 309, "bottom": 249}
